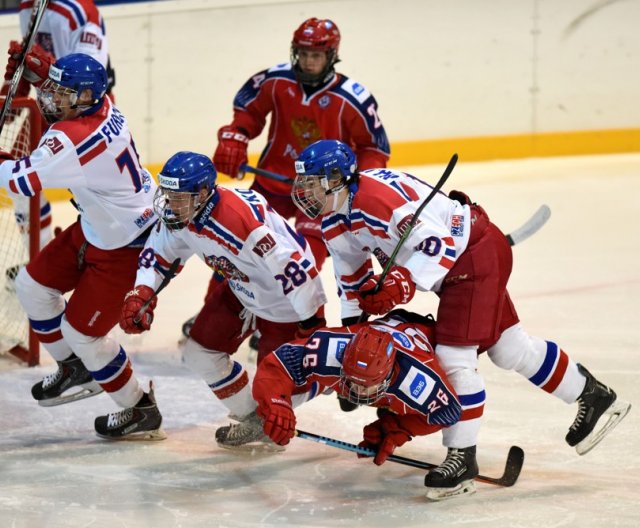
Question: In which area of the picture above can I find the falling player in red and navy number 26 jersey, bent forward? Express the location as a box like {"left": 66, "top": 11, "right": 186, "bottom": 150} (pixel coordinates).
{"left": 253, "top": 310, "right": 464, "bottom": 500}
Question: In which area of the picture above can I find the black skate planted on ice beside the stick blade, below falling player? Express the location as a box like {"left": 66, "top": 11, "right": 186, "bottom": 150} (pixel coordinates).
{"left": 424, "top": 446, "right": 478, "bottom": 501}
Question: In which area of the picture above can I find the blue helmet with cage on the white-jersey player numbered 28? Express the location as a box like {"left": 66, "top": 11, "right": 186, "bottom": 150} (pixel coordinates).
{"left": 153, "top": 151, "right": 218, "bottom": 230}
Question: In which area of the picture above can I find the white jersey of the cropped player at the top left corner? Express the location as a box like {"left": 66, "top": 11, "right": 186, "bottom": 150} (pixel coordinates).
{"left": 20, "top": 0, "right": 109, "bottom": 68}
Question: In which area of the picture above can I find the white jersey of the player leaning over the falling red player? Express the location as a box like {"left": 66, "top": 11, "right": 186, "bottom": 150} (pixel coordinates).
{"left": 322, "top": 169, "right": 471, "bottom": 318}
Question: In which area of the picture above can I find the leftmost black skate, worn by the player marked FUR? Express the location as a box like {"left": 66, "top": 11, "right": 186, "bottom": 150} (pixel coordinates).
{"left": 31, "top": 354, "right": 103, "bottom": 407}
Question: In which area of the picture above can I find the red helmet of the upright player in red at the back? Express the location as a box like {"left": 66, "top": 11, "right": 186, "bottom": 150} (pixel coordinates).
{"left": 291, "top": 17, "right": 340, "bottom": 84}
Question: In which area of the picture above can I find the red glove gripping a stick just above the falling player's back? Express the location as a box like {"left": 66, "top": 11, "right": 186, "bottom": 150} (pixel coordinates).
{"left": 358, "top": 266, "right": 416, "bottom": 315}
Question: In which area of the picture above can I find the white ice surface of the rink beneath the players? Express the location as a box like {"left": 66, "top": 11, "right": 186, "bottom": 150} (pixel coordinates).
{"left": 0, "top": 155, "right": 640, "bottom": 528}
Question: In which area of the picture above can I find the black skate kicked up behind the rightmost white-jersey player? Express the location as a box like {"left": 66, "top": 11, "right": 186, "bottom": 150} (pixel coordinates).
{"left": 565, "top": 364, "right": 631, "bottom": 455}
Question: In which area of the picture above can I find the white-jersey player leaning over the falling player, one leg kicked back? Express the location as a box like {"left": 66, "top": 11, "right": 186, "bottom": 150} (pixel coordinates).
{"left": 292, "top": 140, "right": 630, "bottom": 500}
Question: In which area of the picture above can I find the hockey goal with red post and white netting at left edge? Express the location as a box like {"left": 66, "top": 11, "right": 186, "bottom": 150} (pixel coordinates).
{"left": 0, "top": 97, "right": 42, "bottom": 366}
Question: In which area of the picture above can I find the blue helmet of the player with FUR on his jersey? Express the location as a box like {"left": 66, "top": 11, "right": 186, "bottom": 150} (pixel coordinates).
{"left": 38, "top": 53, "right": 107, "bottom": 123}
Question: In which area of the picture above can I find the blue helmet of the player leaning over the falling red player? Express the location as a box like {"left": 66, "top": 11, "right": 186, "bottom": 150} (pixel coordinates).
{"left": 291, "top": 139, "right": 358, "bottom": 218}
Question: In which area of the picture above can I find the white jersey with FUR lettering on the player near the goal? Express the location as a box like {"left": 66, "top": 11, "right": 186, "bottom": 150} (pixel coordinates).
{"left": 0, "top": 97, "right": 157, "bottom": 249}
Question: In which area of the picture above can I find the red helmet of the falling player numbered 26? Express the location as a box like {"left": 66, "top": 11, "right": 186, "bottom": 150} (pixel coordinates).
{"left": 340, "top": 326, "right": 396, "bottom": 404}
